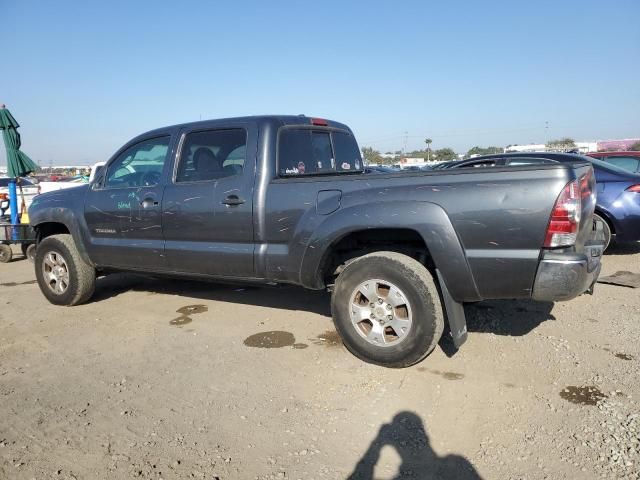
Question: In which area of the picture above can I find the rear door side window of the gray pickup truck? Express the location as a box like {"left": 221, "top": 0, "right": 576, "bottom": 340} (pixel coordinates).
{"left": 176, "top": 128, "right": 247, "bottom": 183}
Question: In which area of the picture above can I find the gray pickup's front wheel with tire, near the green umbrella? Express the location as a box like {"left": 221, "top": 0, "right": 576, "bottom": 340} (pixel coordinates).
{"left": 35, "top": 234, "right": 96, "bottom": 306}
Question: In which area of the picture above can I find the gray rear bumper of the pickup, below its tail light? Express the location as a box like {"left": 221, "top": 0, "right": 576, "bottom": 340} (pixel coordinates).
{"left": 532, "top": 245, "right": 602, "bottom": 302}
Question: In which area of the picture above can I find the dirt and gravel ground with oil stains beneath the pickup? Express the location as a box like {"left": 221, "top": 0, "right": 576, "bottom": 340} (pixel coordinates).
{"left": 0, "top": 244, "right": 640, "bottom": 480}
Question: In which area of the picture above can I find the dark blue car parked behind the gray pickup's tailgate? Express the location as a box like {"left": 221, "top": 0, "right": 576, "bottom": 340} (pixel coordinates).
{"left": 444, "top": 152, "right": 640, "bottom": 249}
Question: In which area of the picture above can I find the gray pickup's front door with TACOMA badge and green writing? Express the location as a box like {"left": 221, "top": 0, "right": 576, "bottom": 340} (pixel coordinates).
{"left": 84, "top": 135, "right": 176, "bottom": 270}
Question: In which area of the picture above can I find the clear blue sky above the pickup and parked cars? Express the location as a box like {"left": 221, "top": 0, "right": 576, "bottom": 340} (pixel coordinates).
{"left": 0, "top": 0, "right": 640, "bottom": 165}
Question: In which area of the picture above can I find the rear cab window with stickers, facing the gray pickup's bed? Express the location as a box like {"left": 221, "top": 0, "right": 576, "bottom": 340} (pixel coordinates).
{"left": 278, "top": 128, "right": 362, "bottom": 177}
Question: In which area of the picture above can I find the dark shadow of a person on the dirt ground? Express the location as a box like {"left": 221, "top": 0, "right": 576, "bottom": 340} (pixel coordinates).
{"left": 347, "top": 411, "right": 481, "bottom": 480}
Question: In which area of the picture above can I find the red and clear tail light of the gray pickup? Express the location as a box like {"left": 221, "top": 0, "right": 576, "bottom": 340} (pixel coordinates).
{"left": 544, "top": 177, "right": 591, "bottom": 248}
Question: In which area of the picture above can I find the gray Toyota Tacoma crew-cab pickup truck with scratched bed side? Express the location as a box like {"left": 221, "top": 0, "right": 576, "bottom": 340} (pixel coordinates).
{"left": 29, "top": 115, "right": 602, "bottom": 367}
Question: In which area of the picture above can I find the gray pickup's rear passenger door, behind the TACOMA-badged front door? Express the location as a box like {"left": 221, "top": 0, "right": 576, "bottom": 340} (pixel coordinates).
{"left": 162, "top": 124, "right": 257, "bottom": 277}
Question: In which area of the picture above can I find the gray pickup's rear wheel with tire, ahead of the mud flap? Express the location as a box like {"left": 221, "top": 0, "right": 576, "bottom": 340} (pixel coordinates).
{"left": 331, "top": 252, "right": 444, "bottom": 368}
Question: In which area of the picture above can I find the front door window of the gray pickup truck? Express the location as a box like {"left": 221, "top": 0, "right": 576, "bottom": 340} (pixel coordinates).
{"left": 104, "top": 136, "right": 171, "bottom": 188}
